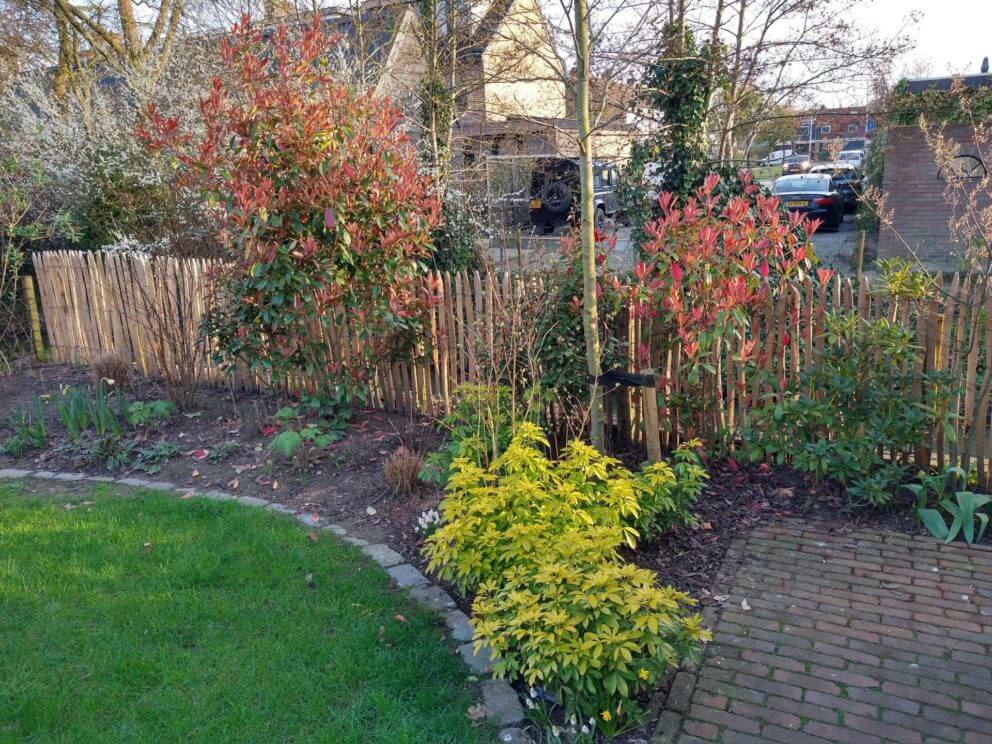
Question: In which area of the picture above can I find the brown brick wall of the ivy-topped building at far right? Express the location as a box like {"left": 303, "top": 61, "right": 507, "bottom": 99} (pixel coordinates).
{"left": 878, "top": 126, "right": 984, "bottom": 270}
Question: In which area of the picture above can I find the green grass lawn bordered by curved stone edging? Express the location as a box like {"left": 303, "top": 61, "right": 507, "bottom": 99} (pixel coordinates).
{"left": 0, "top": 484, "right": 494, "bottom": 744}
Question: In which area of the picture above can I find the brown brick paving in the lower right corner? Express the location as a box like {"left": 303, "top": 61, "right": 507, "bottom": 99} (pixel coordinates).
{"left": 652, "top": 521, "right": 992, "bottom": 744}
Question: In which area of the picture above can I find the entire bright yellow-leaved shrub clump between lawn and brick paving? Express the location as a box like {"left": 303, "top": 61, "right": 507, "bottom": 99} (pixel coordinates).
{"left": 424, "top": 423, "right": 710, "bottom": 728}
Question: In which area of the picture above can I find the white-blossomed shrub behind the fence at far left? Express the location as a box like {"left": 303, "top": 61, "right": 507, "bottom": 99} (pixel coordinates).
{"left": 0, "top": 43, "right": 217, "bottom": 256}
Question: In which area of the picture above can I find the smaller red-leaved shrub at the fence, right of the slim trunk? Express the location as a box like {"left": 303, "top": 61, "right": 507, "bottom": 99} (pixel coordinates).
{"left": 631, "top": 172, "right": 819, "bottom": 438}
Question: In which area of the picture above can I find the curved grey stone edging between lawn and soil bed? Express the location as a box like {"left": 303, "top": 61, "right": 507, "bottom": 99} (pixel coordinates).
{"left": 0, "top": 468, "right": 529, "bottom": 744}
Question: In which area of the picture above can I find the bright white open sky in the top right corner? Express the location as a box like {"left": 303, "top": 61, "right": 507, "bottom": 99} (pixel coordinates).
{"left": 854, "top": 0, "right": 992, "bottom": 76}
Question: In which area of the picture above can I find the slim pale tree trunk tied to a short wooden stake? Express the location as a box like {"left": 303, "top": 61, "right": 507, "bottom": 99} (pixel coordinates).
{"left": 575, "top": 0, "right": 606, "bottom": 452}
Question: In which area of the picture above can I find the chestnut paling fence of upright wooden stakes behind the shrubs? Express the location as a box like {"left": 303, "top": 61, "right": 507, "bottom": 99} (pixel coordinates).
{"left": 33, "top": 251, "right": 992, "bottom": 488}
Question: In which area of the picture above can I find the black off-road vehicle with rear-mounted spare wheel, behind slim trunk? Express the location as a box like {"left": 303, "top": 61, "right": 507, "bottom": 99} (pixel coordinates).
{"left": 530, "top": 157, "right": 620, "bottom": 233}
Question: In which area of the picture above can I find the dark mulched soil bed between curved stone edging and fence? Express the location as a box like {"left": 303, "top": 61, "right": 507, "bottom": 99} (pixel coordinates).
{"left": 0, "top": 363, "right": 442, "bottom": 564}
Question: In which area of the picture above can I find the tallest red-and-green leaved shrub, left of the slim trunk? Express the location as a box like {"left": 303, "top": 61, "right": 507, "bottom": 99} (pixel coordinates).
{"left": 138, "top": 17, "right": 440, "bottom": 404}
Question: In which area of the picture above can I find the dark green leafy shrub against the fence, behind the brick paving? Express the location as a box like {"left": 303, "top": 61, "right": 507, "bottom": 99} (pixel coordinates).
{"left": 743, "top": 313, "right": 953, "bottom": 506}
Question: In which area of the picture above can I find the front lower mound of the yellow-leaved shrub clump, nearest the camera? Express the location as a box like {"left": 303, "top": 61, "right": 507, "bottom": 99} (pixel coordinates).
{"left": 472, "top": 541, "right": 710, "bottom": 717}
